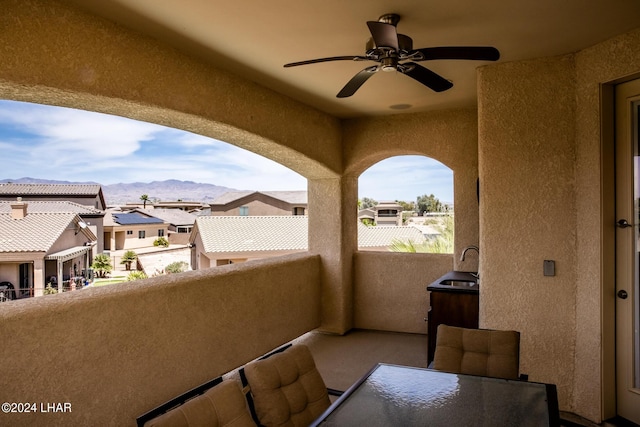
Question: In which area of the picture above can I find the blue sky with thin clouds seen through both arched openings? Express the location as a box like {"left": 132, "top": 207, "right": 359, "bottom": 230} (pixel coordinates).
{"left": 0, "top": 100, "right": 453, "bottom": 202}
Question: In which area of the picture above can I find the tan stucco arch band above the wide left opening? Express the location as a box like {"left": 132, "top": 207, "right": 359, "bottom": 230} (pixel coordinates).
{"left": 0, "top": 0, "right": 342, "bottom": 178}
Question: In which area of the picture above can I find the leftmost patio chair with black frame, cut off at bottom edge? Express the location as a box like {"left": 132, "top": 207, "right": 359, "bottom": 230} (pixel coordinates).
{"left": 136, "top": 377, "right": 256, "bottom": 427}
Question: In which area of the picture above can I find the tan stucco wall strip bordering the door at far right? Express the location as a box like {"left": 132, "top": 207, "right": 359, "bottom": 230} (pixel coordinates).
{"left": 574, "top": 29, "right": 640, "bottom": 421}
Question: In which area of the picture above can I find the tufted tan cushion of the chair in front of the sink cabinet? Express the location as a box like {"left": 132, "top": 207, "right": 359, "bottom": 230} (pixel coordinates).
{"left": 433, "top": 325, "right": 520, "bottom": 379}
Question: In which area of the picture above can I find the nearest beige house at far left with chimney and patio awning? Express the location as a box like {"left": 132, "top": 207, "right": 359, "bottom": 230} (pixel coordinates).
{"left": 0, "top": 201, "right": 97, "bottom": 299}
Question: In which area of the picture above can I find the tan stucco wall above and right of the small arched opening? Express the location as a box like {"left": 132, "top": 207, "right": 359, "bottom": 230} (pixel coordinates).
{"left": 343, "top": 109, "right": 478, "bottom": 271}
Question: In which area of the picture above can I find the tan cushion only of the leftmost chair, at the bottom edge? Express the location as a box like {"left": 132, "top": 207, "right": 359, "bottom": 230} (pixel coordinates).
{"left": 144, "top": 380, "right": 256, "bottom": 427}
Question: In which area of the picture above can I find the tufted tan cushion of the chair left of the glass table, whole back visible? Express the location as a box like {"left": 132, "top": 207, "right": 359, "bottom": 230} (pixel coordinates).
{"left": 245, "top": 345, "right": 330, "bottom": 426}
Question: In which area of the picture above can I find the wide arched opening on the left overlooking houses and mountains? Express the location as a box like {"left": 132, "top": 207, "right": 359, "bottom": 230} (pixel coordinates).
{"left": 0, "top": 100, "right": 308, "bottom": 302}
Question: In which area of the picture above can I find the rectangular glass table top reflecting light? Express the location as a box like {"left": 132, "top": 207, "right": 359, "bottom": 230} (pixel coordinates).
{"left": 317, "top": 364, "right": 557, "bottom": 427}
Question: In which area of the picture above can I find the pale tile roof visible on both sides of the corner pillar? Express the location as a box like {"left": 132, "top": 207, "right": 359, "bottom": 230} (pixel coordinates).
{"left": 196, "top": 216, "right": 425, "bottom": 253}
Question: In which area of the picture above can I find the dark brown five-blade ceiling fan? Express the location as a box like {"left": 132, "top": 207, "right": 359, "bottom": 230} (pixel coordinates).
{"left": 284, "top": 13, "right": 500, "bottom": 98}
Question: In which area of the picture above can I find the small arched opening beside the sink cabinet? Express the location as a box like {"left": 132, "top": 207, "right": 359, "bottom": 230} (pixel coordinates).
{"left": 358, "top": 155, "right": 454, "bottom": 253}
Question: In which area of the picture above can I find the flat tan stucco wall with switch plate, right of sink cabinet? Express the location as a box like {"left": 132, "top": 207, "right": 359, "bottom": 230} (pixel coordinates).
{"left": 478, "top": 56, "right": 576, "bottom": 409}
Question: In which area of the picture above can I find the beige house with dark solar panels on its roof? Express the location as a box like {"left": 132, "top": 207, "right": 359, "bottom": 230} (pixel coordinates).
{"left": 104, "top": 209, "right": 169, "bottom": 251}
